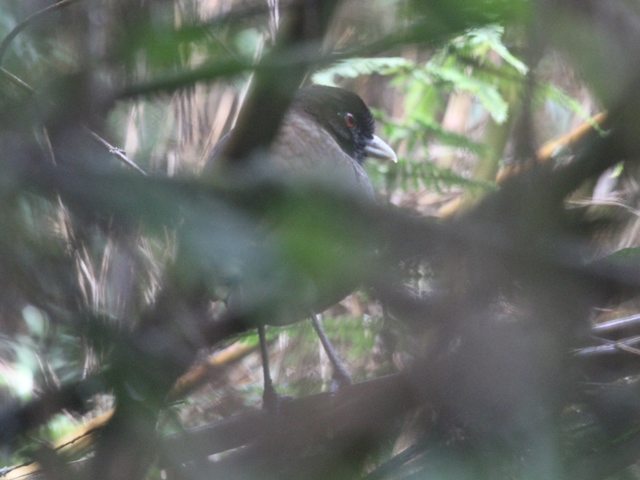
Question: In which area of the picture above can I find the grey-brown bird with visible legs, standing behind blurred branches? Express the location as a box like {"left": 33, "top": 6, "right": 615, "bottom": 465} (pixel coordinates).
{"left": 203, "top": 85, "right": 397, "bottom": 407}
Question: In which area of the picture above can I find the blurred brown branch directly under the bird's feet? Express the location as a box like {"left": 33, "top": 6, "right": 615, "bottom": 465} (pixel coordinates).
{"left": 160, "top": 374, "right": 416, "bottom": 469}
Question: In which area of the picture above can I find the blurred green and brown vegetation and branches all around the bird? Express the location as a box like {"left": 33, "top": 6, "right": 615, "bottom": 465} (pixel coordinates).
{"left": 0, "top": 0, "right": 640, "bottom": 479}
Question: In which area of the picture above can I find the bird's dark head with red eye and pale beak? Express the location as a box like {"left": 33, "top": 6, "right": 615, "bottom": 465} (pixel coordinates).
{"left": 293, "top": 85, "right": 398, "bottom": 164}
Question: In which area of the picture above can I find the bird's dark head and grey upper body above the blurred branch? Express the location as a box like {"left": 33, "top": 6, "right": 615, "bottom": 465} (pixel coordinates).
{"left": 202, "top": 85, "right": 397, "bottom": 195}
